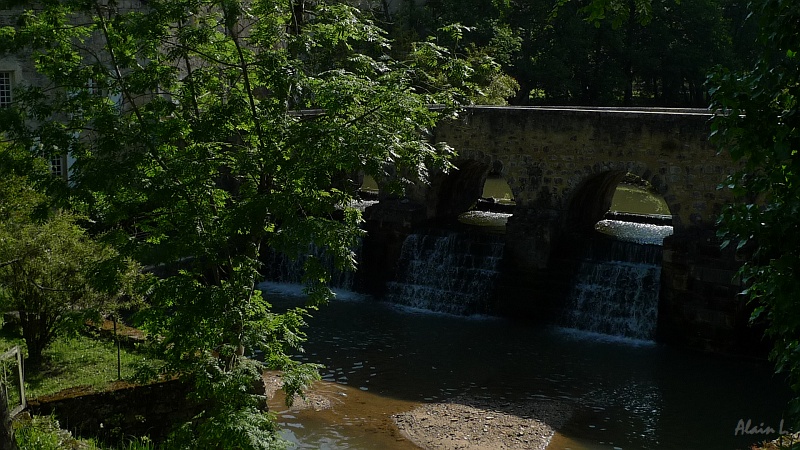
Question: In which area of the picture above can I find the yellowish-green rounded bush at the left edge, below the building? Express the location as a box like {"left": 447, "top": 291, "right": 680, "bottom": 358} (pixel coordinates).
{"left": 0, "top": 151, "right": 133, "bottom": 366}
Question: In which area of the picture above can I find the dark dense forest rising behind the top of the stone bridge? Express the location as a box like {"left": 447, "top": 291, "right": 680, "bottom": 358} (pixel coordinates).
{"left": 373, "top": 0, "right": 758, "bottom": 107}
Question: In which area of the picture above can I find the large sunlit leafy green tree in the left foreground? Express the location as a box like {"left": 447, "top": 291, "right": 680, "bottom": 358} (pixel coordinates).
{"left": 2, "top": 0, "right": 469, "bottom": 448}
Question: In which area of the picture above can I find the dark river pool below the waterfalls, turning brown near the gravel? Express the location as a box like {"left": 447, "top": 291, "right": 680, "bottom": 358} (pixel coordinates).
{"left": 265, "top": 284, "right": 788, "bottom": 450}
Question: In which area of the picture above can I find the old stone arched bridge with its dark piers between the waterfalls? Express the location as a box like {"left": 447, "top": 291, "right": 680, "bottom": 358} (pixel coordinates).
{"left": 367, "top": 107, "right": 763, "bottom": 354}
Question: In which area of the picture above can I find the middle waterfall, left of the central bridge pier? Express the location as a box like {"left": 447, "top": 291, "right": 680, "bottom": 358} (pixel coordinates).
{"left": 386, "top": 231, "right": 504, "bottom": 315}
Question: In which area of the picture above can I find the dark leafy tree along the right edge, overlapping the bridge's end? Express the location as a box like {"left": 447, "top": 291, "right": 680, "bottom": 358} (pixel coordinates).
{"left": 709, "top": 0, "right": 800, "bottom": 413}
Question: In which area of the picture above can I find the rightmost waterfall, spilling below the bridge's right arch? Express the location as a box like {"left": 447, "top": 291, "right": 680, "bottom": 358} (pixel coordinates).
{"left": 561, "top": 240, "right": 661, "bottom": 340}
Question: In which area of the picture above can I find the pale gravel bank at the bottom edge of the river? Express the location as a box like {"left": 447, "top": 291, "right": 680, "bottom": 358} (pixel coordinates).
{"left": 265, "top": 374, "right": 572, "bottom": 450}
